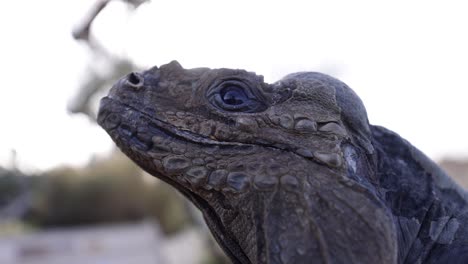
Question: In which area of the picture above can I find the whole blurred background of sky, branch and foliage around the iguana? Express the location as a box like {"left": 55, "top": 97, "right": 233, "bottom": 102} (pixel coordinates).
{"left": 0, "top": 0, "right": 468, "bottom": 264}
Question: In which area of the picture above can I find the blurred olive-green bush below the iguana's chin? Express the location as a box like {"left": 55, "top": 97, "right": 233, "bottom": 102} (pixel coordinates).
{"left": 21, "top": 151, "right": 190, "bottom": 233}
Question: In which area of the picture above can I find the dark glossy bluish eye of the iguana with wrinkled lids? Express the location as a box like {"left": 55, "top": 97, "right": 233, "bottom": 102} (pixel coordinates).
{"left": 208, "top": 79, "right": 266, "bottom": 113}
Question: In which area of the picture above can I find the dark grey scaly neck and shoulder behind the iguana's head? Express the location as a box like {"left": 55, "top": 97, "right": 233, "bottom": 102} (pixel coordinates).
{"left": 372, "top": 127, "right": 468, "bottom": 263}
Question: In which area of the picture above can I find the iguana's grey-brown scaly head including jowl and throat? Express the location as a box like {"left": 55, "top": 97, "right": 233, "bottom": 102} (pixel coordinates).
{"left": 98, "top": 61, "right": 396, "bottom": 264}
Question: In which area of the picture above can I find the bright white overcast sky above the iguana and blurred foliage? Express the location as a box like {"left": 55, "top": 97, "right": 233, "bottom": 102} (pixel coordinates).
{"left": 0, "top": 0, "right": 468, "bottom": 170}
